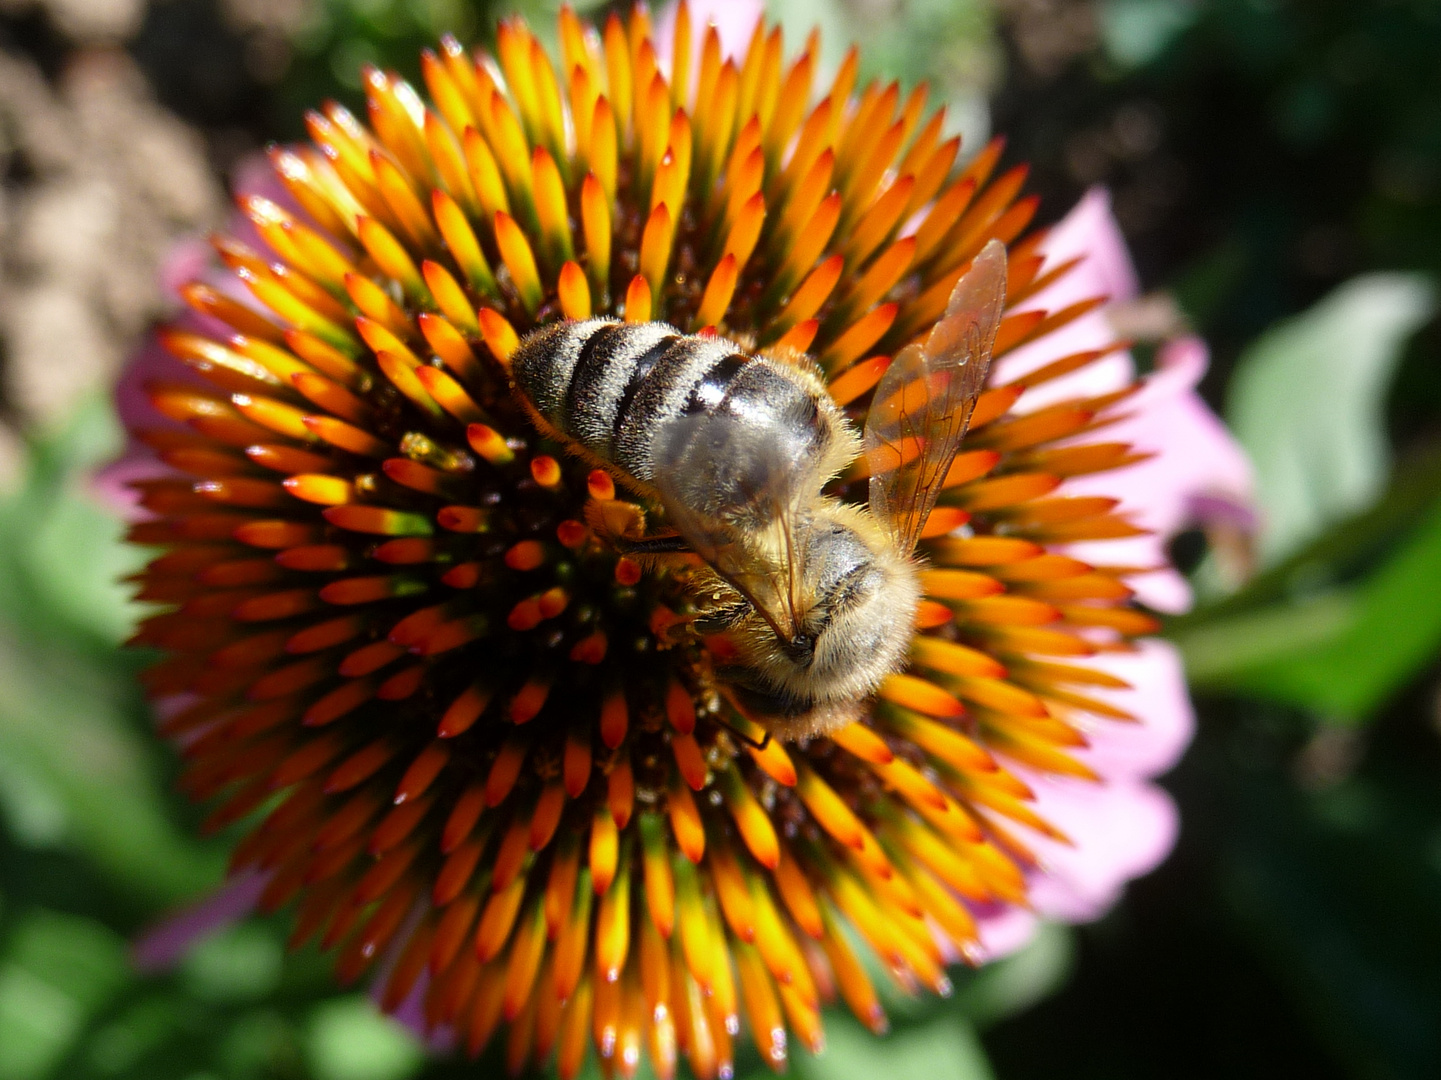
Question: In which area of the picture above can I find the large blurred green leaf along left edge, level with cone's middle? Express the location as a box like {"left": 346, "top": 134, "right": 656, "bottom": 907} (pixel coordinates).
{"left": 0, "top": 399, "right": 222, "bottom": 904}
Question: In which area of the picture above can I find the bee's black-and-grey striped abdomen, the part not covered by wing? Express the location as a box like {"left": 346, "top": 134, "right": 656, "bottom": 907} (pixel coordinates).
{"left": 512, "top": 319, "right": 837, "bottom": 493}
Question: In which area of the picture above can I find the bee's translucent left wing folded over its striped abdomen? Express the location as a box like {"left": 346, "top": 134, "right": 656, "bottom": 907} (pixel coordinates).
{"left": 654, "top": 412, "right": 813, "bottom": 640}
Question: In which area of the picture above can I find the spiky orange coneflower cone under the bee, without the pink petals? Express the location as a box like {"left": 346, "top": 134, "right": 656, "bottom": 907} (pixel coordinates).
{"left": 118, "top": 6, "right": 1233, "bottom": 1076}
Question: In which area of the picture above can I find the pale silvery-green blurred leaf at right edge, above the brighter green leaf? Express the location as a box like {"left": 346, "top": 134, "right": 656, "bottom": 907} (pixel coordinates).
{"left": 1226, "top": 274, "right": 1434, "bottom": 562}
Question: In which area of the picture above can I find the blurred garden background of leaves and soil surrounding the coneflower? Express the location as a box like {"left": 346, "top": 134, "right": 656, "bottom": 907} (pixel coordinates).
{"left": 0, "top": 0, "right": 1441, "bottom": 1080}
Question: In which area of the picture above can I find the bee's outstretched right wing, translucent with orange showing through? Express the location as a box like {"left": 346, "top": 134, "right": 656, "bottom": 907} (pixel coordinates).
{"left": 865, "top": 239, "right": 1006, "bottom": 551}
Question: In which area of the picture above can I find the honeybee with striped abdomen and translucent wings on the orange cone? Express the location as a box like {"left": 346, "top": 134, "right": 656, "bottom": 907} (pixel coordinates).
{"left": 512, "top": 241, "right": 1006, "bottom": 740}
